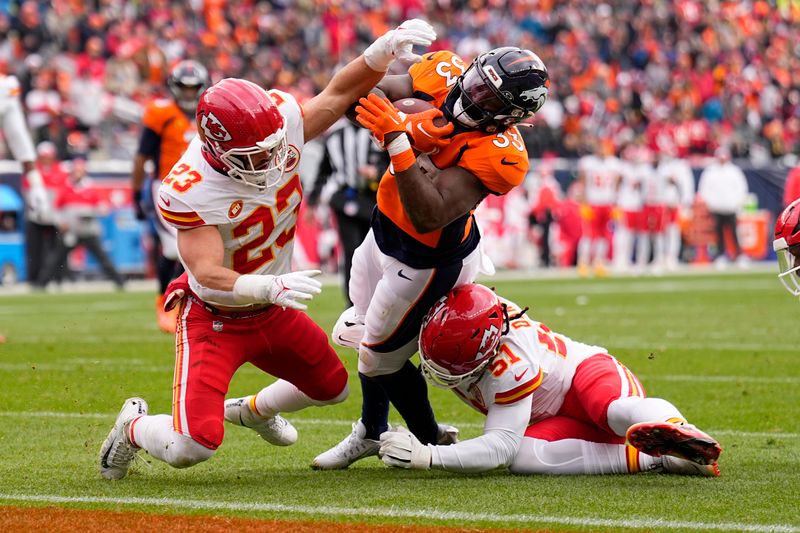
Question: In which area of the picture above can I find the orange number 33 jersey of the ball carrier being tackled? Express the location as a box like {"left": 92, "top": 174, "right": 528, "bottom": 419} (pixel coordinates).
{"left": 378, "top": 51, "right": 529, "bottom": 255}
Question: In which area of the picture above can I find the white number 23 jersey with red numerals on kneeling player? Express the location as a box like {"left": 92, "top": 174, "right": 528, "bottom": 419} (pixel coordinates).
{"left": 157, "top": 91, "right": 304, "bottom": 307}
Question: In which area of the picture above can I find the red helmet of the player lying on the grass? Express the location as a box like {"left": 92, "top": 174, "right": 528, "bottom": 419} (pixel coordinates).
{"left": 419, "top": 284, "right": 505, "bottom": 389}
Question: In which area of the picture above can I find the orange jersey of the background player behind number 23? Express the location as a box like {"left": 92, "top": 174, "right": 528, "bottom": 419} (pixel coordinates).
{"left": 139, "top": 98, "right": 197, "bottom": 180}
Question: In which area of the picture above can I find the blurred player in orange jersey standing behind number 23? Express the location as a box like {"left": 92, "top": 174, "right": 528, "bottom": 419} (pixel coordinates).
{"left": 131, "top": 60, "right": 209, "bottom": 333}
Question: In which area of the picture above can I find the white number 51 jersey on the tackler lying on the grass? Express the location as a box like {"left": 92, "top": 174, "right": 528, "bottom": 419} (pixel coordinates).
{"left": 428, "top": 298, "right": 608, "bottom": 472}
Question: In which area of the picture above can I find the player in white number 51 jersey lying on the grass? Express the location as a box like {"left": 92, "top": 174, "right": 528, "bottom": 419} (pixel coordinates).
{"left": 380, "top": 284, "right": 722, "bottom": 476}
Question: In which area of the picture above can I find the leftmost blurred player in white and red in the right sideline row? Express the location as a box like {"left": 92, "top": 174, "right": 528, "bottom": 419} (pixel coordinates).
{"left": 578, "top": 139, "right": 620, "bottom": 276}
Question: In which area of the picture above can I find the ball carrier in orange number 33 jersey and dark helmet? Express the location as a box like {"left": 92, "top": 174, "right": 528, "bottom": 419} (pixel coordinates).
{"left": 312, "top": 47, "right": 549, "bottom": 469}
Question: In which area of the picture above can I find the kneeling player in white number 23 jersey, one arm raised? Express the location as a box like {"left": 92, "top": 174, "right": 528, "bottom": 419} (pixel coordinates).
{"left": 100, "top": 19, "right": 436, "bottom": 479}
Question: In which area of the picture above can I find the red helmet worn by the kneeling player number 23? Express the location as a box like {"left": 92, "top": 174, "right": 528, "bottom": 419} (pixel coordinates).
{"left": 197, "top": 78, "right": 289, "bottom": 189}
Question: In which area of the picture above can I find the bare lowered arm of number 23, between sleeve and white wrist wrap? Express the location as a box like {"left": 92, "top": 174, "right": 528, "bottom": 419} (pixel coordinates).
{"left": 178, "top": 226, "right": 239, "bottom": 291}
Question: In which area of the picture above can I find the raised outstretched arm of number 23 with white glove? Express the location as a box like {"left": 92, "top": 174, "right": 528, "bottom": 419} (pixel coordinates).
{"left": 303, "top": 19, "right": 436, "bottom": 141}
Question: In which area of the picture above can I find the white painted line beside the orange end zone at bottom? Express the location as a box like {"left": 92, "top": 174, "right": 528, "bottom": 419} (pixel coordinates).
{"left": 0, "top": 493, "right": 800, "bottom": 533}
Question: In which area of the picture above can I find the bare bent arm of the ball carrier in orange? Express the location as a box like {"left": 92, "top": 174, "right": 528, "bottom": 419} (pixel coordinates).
{"left": 397, "top": 156, "right": 490, "bottom": 233}
